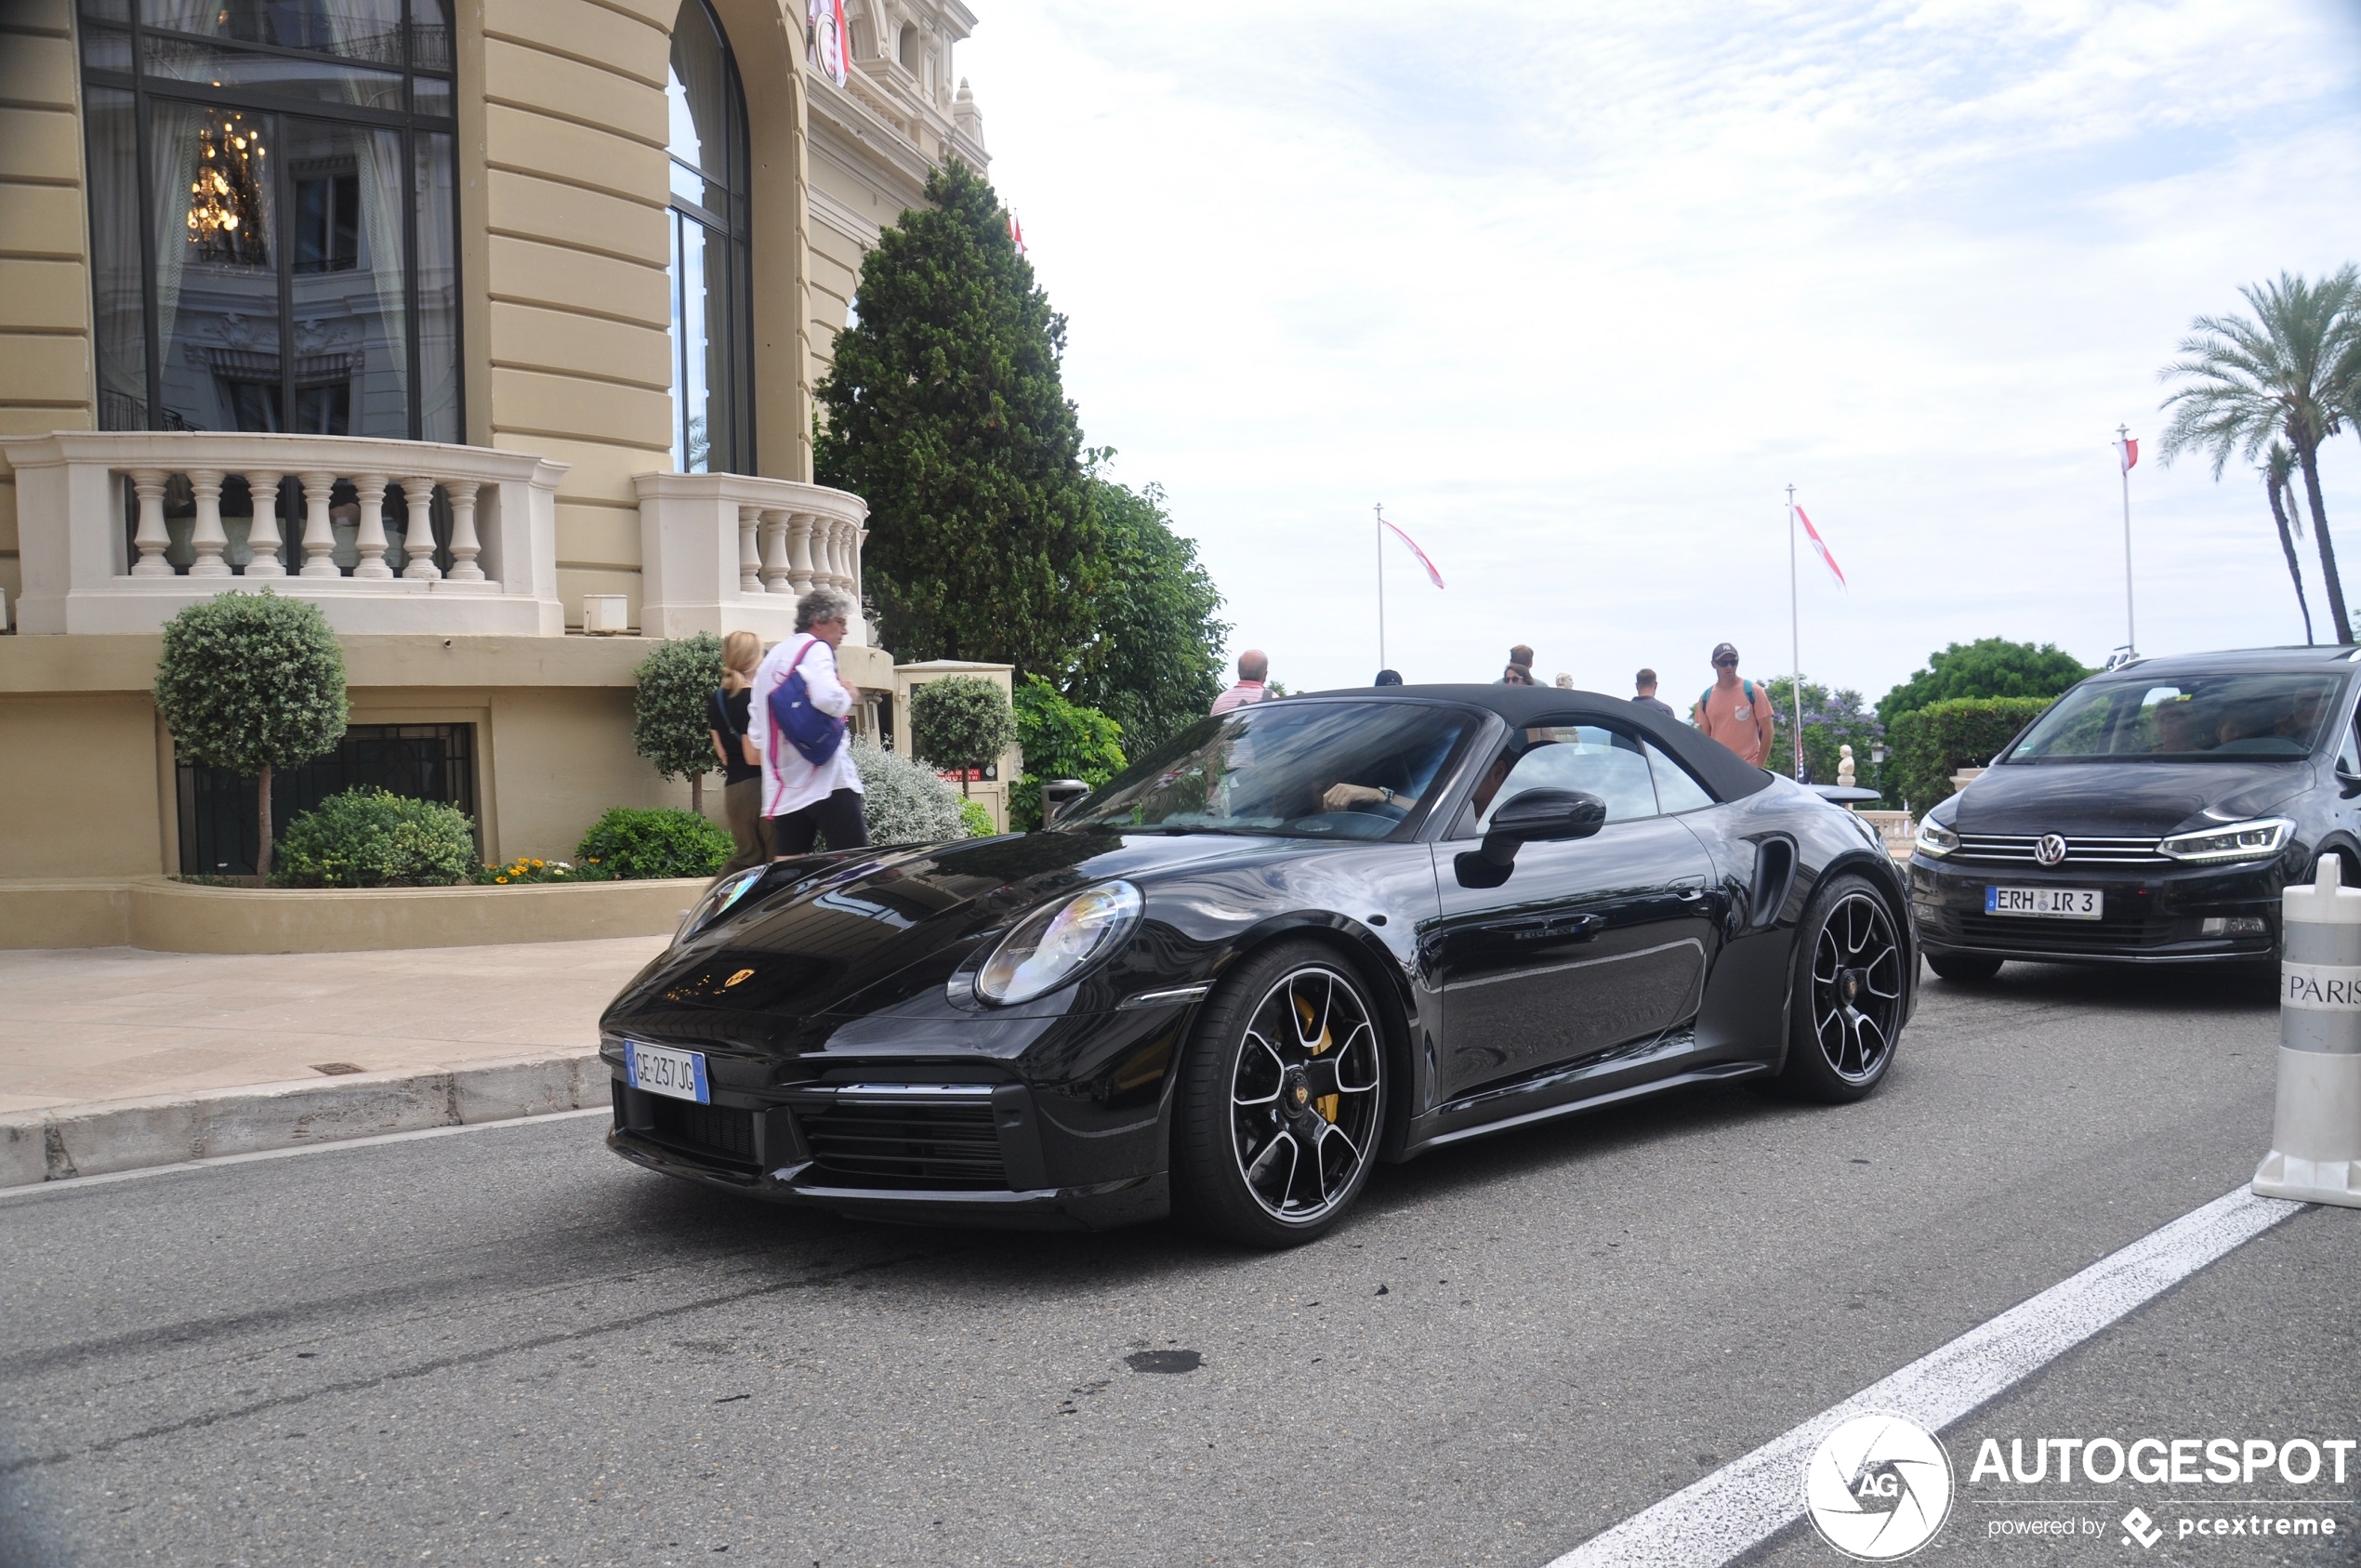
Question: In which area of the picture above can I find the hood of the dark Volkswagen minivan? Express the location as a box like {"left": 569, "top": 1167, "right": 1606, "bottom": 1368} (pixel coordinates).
{"left": 1941, "top": 760, "right": 2312, "bottom": 838}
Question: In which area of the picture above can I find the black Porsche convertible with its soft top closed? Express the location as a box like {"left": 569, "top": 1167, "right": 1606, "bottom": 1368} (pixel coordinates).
{"left": 602, "top": 687, "right": 1917, "bottom": 1246}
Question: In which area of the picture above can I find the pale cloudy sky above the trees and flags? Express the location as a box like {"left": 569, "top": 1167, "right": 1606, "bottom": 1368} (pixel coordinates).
{"left": 958, "top": 0, "right": 2361, "bottom": 699}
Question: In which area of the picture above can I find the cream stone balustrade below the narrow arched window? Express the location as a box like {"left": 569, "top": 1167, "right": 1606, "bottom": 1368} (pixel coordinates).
{"left": 633, "top": 475, "right": 869, "bottom": 645}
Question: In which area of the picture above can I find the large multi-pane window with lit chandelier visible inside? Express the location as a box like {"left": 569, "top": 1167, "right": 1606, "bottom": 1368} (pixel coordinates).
{"left": 80, "top": 0, "right": 463, "bottom": 441}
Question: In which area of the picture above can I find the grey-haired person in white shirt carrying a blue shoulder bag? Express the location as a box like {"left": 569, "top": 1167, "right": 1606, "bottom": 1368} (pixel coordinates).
{"left": 746, "top": 588, "right": 869, "bottom": 860}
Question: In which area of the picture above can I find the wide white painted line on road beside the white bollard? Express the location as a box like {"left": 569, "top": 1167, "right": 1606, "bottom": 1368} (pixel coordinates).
{"left": 1549, "top": 1188, "right": 2312, "bottom": 1568}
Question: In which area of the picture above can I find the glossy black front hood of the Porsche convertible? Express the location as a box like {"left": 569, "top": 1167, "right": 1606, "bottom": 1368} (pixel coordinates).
{"left": 607, "top": 831, "right": 1301, "bottom": 1027}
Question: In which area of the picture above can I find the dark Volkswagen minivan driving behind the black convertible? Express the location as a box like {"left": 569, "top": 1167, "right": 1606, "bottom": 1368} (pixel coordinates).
{"left": 1910, "top": 647, "right": 2361, "bottom": 980}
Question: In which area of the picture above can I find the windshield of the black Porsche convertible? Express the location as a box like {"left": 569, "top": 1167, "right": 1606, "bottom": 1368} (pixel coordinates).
{"left": 1058, "top": 702, "right": 1476, "bottom": 838}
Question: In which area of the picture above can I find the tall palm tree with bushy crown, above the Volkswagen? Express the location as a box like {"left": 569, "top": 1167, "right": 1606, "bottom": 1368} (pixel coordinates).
{"left": 2158, "top": 265, "right": 2361, "bottom": 642}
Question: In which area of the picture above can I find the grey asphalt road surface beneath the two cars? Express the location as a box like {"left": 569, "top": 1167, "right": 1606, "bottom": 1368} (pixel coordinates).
{"left": 0, "top": 966, "right": 2361, "bottom": 1568}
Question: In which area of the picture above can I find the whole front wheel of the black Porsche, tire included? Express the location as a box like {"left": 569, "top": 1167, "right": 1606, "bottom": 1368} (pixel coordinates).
{"left": 1173, "top": 942, "right": 1386, "bottom": 1246}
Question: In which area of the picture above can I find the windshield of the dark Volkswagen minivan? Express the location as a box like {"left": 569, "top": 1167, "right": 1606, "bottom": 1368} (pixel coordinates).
{"left": 2010, "top": 673, "right": 2344, "bottom": 763}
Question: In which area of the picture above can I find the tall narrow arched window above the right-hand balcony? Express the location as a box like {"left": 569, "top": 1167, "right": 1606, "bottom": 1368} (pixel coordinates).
{"left": 666, "top": 0, "right": 753, "bottom": 475}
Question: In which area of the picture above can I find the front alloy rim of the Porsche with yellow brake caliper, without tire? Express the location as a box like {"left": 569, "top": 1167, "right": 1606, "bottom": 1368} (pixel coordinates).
{"left": 1230, "top": 966, "right": 1383, "bottom": 1223}
